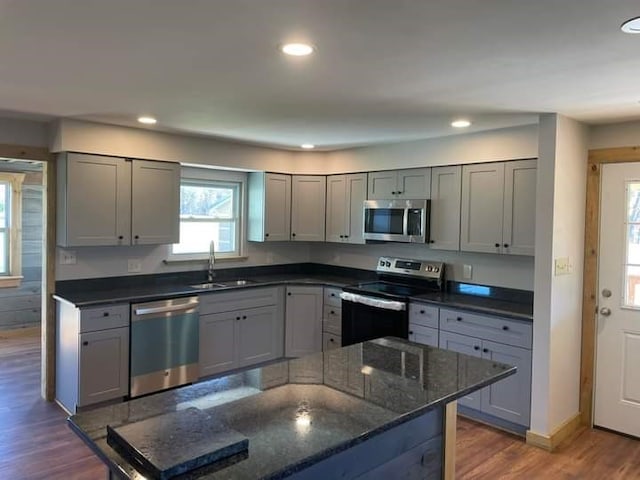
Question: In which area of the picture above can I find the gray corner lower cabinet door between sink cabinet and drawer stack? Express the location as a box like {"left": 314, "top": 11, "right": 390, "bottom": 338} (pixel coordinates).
{"left": 285, "top": 287, "right": 322, "bottom": 357}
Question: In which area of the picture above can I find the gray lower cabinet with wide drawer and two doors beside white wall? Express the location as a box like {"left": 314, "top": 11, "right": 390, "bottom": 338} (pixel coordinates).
{"left": 440, "top": 308, "right": 532, "bottom": 427}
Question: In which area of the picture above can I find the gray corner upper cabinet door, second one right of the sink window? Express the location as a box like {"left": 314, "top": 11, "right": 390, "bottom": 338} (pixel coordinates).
{"left": 291, "top": 175, "right": 327, "bottom": 242}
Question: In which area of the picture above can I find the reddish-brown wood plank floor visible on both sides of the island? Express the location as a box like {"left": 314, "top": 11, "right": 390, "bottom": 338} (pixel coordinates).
{"left": 0, "top": 332, "right": 640, "bottom": 480}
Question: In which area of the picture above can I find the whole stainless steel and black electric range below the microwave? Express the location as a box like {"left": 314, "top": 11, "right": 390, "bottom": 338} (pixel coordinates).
{"left": 341, "top": 257, "right": 445, "bottom": 346}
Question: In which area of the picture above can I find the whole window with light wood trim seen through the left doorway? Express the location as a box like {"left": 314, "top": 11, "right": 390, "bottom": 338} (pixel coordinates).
{"left": 0, "top": 172, "right": 24, "bottom": 287}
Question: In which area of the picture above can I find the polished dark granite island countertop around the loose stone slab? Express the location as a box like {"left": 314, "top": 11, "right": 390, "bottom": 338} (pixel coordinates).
{"left": 69, "top": 337, "right": 515, "bottom": 480}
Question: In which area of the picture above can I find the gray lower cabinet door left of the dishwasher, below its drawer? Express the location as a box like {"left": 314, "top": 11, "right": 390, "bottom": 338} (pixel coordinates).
{"left": 78, "top": 327, "right": 129, "bottom": 407}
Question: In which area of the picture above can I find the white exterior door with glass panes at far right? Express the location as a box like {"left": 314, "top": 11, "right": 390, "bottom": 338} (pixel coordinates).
{"left": 594, "top": 163, "right": 640, "bottom": 437}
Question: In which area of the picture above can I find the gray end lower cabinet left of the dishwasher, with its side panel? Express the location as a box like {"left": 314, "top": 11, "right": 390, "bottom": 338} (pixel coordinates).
{"left": 56, "top": 301, "right": 129, "bottom": 413}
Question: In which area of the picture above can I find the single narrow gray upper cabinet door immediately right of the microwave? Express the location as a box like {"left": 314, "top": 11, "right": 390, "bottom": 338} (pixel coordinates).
{"left": 429, "top": 165, "right": 462, "bottom": 250}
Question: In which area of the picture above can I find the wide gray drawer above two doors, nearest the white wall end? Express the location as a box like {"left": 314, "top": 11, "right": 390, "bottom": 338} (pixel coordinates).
{"left": 440, "top": 308, "right": 532, "bottom": 349}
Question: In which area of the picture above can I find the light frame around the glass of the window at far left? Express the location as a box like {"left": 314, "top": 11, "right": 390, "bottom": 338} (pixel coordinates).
{"left": 0, "top": 172, "right": 25, "bottom": 288}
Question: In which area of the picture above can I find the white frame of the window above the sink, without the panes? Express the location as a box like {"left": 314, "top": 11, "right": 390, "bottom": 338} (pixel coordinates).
{"left": 166, "top": 165, "right": 247, "bottom": 263}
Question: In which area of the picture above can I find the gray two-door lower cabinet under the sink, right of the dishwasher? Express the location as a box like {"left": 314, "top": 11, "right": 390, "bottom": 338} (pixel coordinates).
{"left": 199, "top": 288, "right": 283, "bottom": 377}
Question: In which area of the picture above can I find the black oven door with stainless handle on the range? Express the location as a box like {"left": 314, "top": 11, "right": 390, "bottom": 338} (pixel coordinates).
{"left": 340, "top": 292, "right": 409, "bottom": 347}
